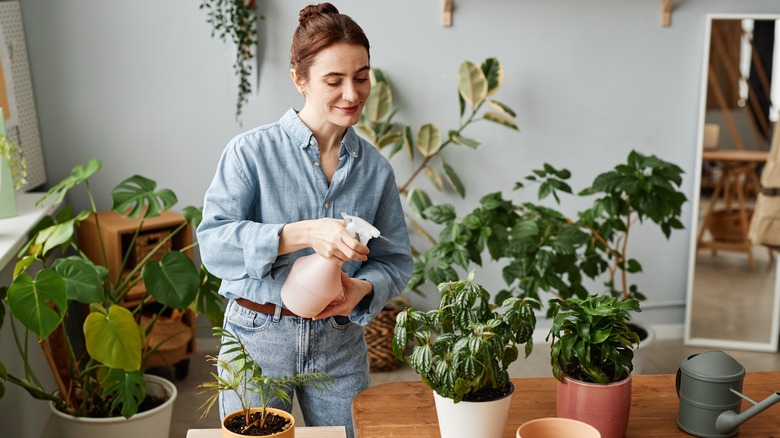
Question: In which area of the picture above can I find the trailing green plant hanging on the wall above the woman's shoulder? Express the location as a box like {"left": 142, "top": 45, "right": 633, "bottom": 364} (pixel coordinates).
{"left": 200, "top": 0, "right": 265, "bottom": 120}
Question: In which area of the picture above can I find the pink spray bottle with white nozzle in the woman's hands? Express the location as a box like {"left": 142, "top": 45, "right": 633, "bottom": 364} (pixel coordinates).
{"left": 281, "top": 213, "right": 379, "bottom": 318}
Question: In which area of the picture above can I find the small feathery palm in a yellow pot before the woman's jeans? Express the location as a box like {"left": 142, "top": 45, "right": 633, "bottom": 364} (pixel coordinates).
{"left": 198, "top": 327, "right": 333, "bottom": 438}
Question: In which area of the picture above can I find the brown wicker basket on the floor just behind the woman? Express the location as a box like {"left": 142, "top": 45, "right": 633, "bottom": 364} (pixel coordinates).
{"left": 364, "top": 296, "right": 409, "bottom": 372}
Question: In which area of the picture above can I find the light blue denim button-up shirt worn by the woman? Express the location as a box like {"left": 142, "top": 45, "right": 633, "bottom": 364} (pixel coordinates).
{"left": 197, "top": 109, "right": 412, "bottom": 325}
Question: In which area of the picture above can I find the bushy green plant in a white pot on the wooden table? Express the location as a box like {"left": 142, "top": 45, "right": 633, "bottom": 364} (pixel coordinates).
{"left": 393, "top": 271, "right": 541, "bottom": 438}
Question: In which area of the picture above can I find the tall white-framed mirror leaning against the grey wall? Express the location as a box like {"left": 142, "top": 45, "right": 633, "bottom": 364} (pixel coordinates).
{"left": 685, "top": 15, "right": 780, "bottom": 351}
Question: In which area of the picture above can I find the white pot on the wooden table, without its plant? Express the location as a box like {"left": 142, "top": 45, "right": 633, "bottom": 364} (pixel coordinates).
{"left": 433, "top": 386, "right": 514, "bottom": 438}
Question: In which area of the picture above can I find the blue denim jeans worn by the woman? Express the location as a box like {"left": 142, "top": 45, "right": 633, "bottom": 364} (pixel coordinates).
{"left": 219, "top": 300, "right": 369, "bottom": 437}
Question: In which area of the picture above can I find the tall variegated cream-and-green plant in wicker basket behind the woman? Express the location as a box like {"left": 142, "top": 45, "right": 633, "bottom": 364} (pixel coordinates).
{"left": 355, "top": 58, "right": 519, "bottom": 371}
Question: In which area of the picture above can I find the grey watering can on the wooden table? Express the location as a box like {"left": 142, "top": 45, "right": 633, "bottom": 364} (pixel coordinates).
{"left": 677, "top": 351, "right": 780, "bottom": 438}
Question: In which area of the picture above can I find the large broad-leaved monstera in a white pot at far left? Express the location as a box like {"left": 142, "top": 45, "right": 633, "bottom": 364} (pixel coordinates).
{"left": 0, "top": 158, "right": 219, "bottom": 437}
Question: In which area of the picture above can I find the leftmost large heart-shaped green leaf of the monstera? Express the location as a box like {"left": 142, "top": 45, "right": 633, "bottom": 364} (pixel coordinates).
{"left": 7, "top": 269, "right": 68, "bottom": 339}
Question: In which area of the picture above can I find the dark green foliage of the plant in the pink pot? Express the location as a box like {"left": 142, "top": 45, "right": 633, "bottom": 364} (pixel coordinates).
{"left": 546, "top": 295, "right": 640, "bottom": 384}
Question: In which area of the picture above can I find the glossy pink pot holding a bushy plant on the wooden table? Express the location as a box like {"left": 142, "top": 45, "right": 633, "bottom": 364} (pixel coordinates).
{"left": 556, "top": 376, "right": 631, "bottom": 438}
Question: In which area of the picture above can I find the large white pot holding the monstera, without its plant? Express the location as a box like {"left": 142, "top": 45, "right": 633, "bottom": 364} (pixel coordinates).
{"left": 49, "top": 374, "right": 177, "bottom": 438}
